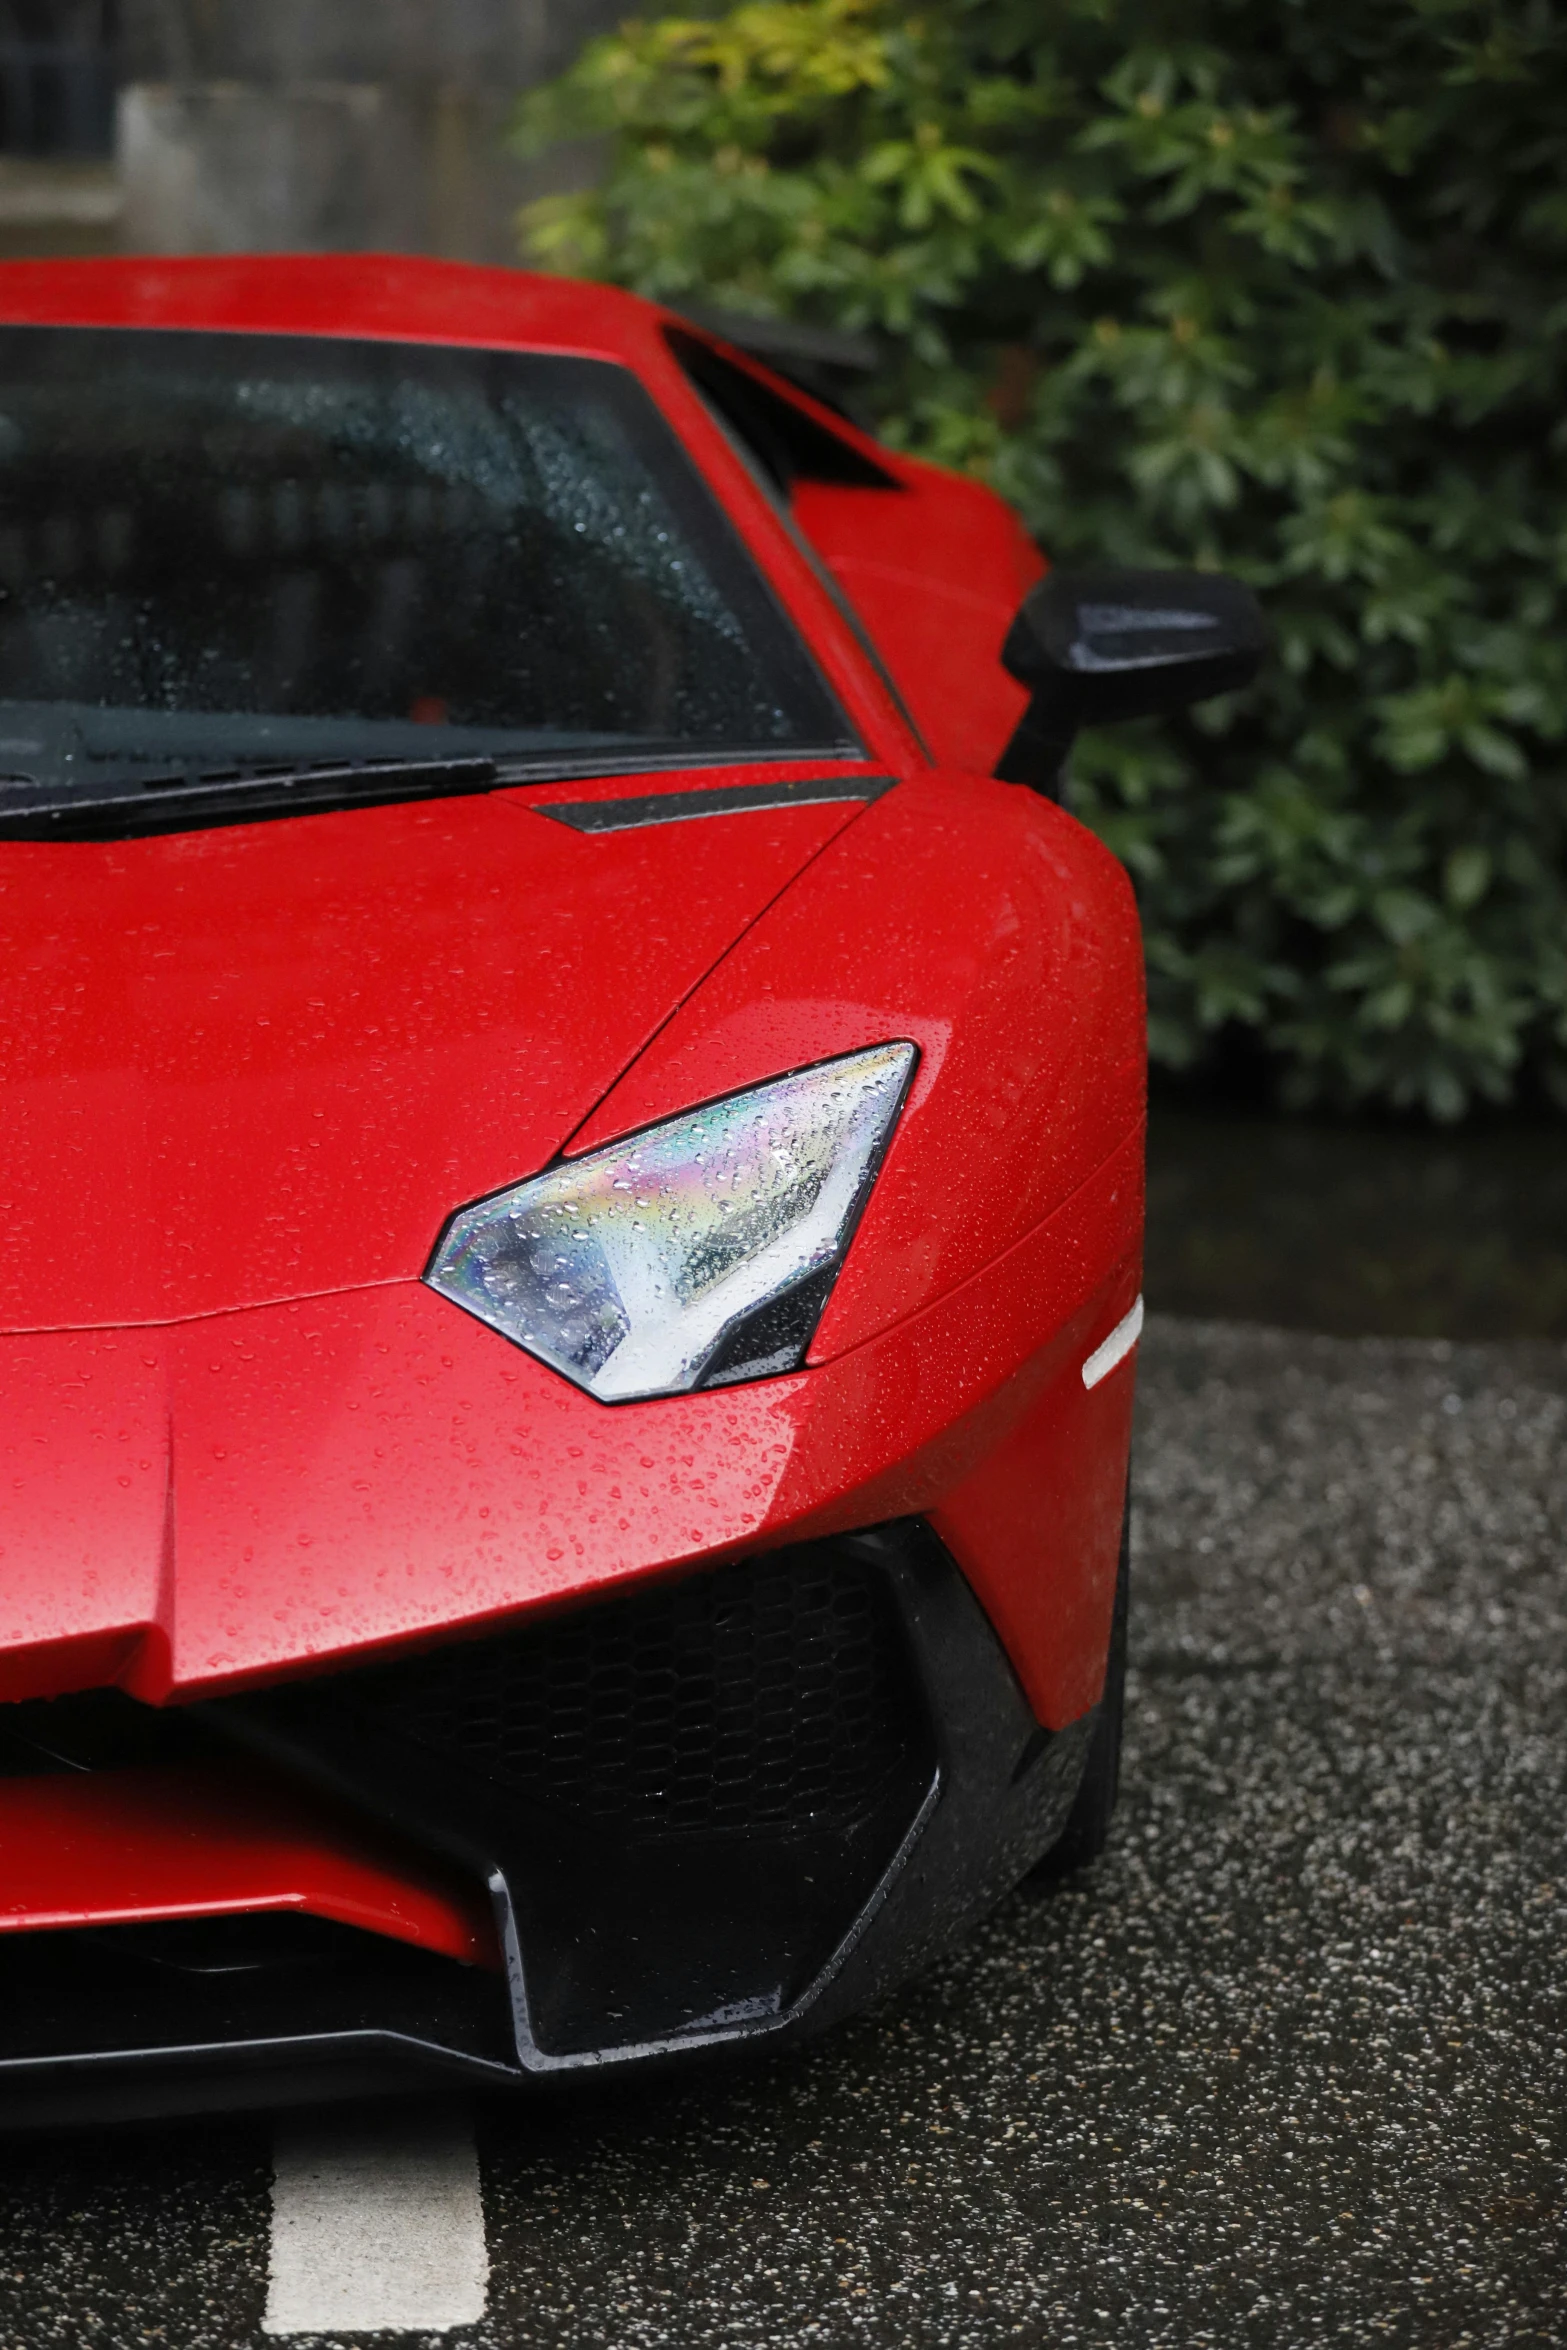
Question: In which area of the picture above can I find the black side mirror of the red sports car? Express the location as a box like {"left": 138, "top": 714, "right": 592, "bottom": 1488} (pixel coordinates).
{"left": 996, "top": 571, "right": 1269, "bottom": 799}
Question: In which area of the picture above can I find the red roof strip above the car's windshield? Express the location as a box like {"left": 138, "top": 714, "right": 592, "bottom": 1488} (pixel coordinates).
{"left": 0, "top": 254, "right": 665, "bottom": 364}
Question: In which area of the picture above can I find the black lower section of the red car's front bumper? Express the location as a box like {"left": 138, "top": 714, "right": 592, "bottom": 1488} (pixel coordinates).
{"left": 0, "top": 1518, "right": 1095, "bottom": 2124}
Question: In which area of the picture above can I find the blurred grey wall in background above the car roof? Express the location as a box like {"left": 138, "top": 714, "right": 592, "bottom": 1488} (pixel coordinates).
{"left": 0, "top": 0, "right": 625, "bottom": 261}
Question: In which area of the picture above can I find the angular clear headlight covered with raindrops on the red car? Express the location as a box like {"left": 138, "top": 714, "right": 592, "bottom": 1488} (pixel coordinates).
{"left": 425, "top": 1043, "right": 916, "bottom": 1403}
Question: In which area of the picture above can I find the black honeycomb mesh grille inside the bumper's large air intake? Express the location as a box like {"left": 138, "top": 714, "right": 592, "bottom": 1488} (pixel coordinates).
{"left": 336, "top": 1544, "right": 923, "bottom": 1835}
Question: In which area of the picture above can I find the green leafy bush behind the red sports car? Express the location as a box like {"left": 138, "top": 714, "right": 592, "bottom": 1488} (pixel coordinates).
{"left": 519, "top": 0, "right": 1567, "bottom": 1119}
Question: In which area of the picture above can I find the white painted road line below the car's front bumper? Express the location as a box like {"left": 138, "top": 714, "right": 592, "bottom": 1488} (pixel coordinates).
{"left": 261, "top": 2106, "right": 489, "bottom": 2334}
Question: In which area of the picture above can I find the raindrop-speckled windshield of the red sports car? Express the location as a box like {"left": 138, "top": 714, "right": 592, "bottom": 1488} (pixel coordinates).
{"left": 0, "top": 327, "right": 850, "bottom": 811}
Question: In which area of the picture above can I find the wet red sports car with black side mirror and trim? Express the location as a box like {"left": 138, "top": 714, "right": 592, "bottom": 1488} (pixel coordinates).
{"left": 0, "top": 259, "right": 1262, "bottom": 2120}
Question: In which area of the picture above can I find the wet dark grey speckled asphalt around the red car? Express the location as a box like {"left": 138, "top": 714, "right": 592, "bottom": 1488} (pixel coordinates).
{"left": 0, "top": 1321, "right": 1567, "bottom": 2350}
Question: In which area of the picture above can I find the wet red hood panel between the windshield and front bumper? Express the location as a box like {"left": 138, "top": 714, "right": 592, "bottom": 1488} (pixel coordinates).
{"left": 0, "top": 768, "right": 858, "bottom": 1332}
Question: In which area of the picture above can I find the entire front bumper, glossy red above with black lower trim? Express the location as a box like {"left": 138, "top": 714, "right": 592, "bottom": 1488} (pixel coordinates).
{"left": 0, "top": 1137, "right": 1142, "bottom": 2122}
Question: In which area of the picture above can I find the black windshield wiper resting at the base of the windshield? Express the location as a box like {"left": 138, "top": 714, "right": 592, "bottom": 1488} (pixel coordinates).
{"left": 0, "top": 759, "right": 500, "bottom": 841}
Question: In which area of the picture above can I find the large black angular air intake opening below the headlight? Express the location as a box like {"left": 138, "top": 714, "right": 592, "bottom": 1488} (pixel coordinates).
{"left": 223, "top": 1537, "right": 935, "bottom": 2068}
